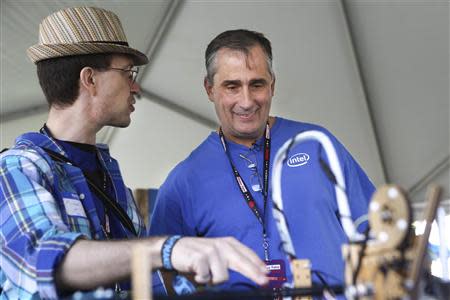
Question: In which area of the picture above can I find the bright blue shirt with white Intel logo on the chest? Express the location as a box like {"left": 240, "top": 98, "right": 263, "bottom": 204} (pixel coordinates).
{"left": 150, "top": 118, "right": 374, "bottom": 290}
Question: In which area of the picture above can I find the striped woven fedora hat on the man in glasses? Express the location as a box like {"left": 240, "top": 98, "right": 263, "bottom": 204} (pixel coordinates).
{"left": 27, "top": 7, "right": 148, "bottom": 65}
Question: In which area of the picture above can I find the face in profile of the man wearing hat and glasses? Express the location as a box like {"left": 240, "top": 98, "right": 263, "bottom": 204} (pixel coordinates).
{"left": 95, "top": 55, "right": 139, "bottom": 127}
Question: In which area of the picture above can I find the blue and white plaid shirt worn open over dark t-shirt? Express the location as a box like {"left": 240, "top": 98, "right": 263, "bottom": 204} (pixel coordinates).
{"left": 0, "top": 133, "right": 145, "bottom": 299}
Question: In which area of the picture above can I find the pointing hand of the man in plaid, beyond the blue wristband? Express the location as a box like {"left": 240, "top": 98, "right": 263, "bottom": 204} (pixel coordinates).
{"left": 171, "top": 237, "right": 268, "bottom": 285}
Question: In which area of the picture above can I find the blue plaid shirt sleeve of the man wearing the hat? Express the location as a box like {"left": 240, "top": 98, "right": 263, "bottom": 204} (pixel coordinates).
{"left": 0, "top": 154, "right": 82, "bottom": 299}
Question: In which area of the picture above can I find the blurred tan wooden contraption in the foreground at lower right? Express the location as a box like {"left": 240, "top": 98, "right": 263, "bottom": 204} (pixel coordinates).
{"left": 342, "top": 185, "right": 439, "bottom": 300}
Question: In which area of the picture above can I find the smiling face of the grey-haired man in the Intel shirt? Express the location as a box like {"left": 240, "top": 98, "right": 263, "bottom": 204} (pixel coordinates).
{"left": 205, "top": 46, "right": 275, "bottom": 145}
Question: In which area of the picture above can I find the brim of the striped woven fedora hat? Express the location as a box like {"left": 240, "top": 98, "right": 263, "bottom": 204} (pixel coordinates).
{"left": 27, "top": 42, "right": 148, "bottom": 66}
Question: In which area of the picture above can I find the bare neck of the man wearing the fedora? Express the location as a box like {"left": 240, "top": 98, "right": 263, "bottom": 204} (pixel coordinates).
{"left": 46, "top": 106, "right": 100, "bottom": 145}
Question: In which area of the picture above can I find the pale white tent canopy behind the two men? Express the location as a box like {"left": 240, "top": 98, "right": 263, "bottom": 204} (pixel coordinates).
{"left": 0, "top": 0, "right": 450, "bottom": 219}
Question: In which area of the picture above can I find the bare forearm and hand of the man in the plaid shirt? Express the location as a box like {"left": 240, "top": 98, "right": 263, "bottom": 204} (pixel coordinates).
{"left": 55, "top": 236, "right": 268, "bottom": 292}
